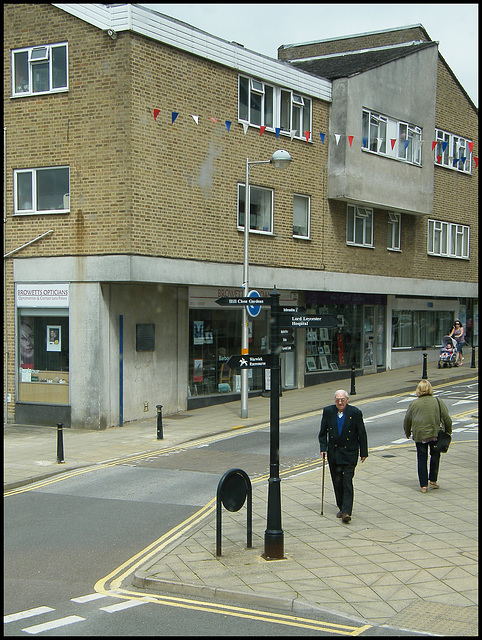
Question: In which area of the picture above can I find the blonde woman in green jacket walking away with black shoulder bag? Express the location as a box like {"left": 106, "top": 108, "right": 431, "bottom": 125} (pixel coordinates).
{"left": 403, "top": 380, "right": 452, "bottom": 493}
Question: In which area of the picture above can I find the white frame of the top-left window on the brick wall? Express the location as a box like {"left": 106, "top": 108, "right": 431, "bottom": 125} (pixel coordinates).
{"left": 11, "top": 42, "right": 69, "bottom": 98}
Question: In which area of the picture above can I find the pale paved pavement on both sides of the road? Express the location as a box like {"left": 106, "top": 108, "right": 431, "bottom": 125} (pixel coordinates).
{"left": 4, "top": 363, "right": 478, "bottom": 636}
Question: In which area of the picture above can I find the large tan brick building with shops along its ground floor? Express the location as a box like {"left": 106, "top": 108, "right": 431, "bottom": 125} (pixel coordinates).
{"left": 4, "top": 4, "right": 478, "bottom": 429}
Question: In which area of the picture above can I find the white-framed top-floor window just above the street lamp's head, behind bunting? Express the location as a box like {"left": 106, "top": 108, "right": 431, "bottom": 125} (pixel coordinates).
{"left": 238, "top": 75, "right": 313, "bottom": 141}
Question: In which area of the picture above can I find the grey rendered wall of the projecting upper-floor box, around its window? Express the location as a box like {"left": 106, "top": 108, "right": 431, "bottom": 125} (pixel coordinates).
{"left": 328, "top": 46, "right": 437, "bottom": 215}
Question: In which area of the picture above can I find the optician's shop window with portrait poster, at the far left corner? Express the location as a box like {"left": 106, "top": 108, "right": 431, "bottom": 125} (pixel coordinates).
{"left": 18, "top": 309, "right": 69, "bottom": 404}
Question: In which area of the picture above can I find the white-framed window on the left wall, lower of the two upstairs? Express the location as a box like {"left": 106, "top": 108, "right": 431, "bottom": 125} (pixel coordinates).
{"left": 14, "top": 167, "right": 70, "bottom": 214}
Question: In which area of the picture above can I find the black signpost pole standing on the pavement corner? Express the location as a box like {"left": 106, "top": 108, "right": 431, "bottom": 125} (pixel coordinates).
{"left": 263, "top": 287, "right": 284, "bottom": 560}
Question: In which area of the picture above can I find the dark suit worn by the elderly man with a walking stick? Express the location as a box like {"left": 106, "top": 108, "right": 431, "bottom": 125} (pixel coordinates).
{"left": 318, "top": 404, "right": 368, "bottom": 516}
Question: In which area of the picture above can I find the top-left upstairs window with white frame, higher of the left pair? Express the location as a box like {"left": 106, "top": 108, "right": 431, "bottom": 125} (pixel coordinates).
{"left": 12, "top": 42, "right": 68, "bottom": 96}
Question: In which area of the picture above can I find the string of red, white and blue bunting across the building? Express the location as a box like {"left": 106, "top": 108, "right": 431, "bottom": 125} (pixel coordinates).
{"left": 153, "top": 108, "right": 479, "bottom": 168}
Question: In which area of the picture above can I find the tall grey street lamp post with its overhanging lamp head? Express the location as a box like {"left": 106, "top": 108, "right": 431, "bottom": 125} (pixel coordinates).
{"left": 241, "top": 149, "right": 291, "bottom": 418}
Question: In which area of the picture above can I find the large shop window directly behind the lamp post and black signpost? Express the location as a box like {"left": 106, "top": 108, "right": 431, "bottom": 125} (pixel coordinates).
{"left": 189, "top": 309, "right": 269, "bottom": 397}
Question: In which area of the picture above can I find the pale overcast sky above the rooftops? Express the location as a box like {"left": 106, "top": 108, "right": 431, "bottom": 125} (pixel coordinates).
{"left": 142, "top": 3, "right": 479, "bottom": 107}
